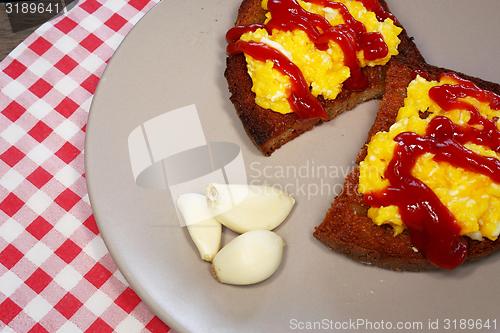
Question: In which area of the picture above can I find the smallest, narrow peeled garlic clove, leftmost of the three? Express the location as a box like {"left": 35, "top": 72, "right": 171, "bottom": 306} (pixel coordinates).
{"left": 177, "top": 193, "right": 222, "bottom": 261}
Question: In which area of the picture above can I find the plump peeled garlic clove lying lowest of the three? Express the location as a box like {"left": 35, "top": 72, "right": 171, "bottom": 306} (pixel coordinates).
{"left": 212, "top": 230, "right": 285, "bottom": 285}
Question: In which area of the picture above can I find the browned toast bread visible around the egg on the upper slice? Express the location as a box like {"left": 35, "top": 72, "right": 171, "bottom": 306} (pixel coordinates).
{"left": 225, "top": 0, "right": 423, "bottom": 155}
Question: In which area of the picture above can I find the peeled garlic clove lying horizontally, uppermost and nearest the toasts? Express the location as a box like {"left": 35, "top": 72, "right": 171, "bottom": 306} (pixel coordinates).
{"left": 207, "top": 184, "right": 295, "bottom": 233}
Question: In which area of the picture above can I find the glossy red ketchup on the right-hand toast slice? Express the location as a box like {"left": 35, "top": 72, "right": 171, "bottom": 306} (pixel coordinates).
{"left": 364, "top": 75, "right": 500, "bottom": 269}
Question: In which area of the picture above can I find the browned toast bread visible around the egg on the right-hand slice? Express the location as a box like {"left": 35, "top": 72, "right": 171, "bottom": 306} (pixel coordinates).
{"left": 314, "top": 62, "right": 500, "bottom": 271}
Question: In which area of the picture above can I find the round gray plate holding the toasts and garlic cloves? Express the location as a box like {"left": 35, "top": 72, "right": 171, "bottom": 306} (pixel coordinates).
{"left": 86, "top": 0, "right": 500, "bottom": 332}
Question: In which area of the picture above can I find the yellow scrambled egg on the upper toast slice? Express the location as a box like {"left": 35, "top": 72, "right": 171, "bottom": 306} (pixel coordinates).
{"left": 241, "top": 0, "right": 402, "bottom": 113}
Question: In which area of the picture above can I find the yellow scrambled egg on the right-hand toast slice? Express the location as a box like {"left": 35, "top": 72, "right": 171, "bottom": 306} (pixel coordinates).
{"left": 359, "top": 76, "right": 500, "bottom": 240}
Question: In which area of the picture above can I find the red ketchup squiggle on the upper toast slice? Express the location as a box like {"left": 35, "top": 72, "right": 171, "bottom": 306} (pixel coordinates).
{"left": 226, "top": 0, "right": 389, "bottom": 120}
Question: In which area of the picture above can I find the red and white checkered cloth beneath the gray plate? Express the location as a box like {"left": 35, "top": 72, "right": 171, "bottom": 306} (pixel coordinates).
{"left": 0, "top": 0, "right": 169, "bottom": 332}
